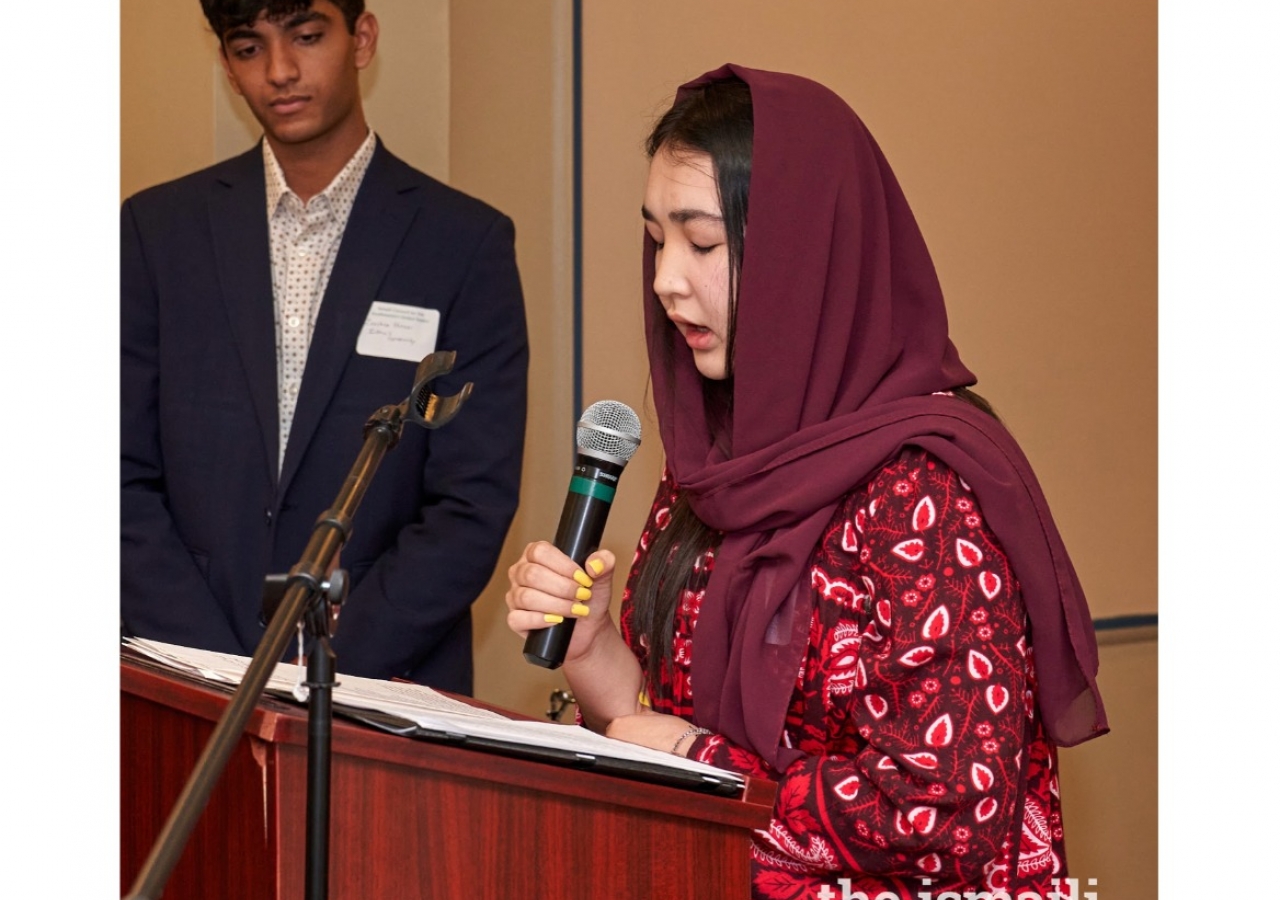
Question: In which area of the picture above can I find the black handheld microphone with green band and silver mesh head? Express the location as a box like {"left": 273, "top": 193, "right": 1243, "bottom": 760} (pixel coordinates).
{"left": 525, "top": 399, "right": 640, "bottom": 668}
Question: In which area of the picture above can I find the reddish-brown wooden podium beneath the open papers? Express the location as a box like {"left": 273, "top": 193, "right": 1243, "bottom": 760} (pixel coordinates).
{"left": 120, "top": 661, "right": 774, "bottom": 900}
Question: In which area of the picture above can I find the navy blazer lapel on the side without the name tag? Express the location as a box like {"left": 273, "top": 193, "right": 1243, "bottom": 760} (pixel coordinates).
{"left": 209, "top": 148, "right": 279, "bottom": 480}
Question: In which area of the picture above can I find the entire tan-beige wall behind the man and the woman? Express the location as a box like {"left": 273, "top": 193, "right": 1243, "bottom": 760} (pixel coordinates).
{"left": 120, "top": 0, "right": 1157, "bottom": 900}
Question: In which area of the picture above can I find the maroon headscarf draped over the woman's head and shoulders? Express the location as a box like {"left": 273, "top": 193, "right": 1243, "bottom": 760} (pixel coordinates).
{"left": 644, "top": 65, "right": 1107, "bottom": 771}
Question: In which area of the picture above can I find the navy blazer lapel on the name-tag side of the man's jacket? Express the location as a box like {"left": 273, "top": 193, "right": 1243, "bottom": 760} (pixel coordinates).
{"left": 280, "top": 141, "right": 416, "bottom": 495}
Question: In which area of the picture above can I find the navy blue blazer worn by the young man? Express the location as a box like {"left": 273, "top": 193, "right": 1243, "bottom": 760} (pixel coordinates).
{"left": 120, "top": 143, "right": 529, "bottom": 693}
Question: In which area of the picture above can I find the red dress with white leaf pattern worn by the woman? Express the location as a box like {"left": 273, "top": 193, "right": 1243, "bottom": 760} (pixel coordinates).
{"left": 620, "top": 447, "right": 1066, "bottom": 900}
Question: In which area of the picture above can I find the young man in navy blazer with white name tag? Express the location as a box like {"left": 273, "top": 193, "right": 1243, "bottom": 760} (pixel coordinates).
{"left": 120, "top": 0, "right": 529, "bottom": 693}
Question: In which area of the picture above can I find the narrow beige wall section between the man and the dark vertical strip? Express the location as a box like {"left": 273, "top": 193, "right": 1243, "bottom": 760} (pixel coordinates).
{"left": 451, "top": 0, "right": 577, "bottom": 716}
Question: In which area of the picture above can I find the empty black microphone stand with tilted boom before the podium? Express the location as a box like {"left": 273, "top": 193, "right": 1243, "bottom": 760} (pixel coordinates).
{"left": 125, "top": 351, "right": 472, "bottom": 900}
